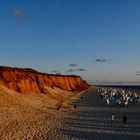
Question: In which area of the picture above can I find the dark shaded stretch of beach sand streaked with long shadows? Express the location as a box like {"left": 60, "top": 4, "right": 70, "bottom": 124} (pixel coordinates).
{"left": 52, "top": 87, "right": 140, "bottom": 140}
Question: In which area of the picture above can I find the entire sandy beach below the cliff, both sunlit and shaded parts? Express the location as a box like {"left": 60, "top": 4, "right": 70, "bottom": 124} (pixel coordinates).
{"left": 0, "top": 88, "right": 140, "bottom": 140}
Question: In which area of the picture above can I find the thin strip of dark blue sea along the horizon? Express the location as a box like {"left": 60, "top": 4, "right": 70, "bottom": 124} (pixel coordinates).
{"left": 97, "top": 85, "right": 140, "bottom": 90}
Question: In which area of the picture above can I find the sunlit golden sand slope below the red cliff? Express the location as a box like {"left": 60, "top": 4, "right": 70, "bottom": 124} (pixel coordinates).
{"left": 0, "top": 86, "right": 72, "bottom": 140}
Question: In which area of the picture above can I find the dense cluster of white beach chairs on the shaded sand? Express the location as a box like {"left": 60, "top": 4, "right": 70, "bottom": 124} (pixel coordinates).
{"left": 97, "top": 88, "right": 140, "bottom": 107}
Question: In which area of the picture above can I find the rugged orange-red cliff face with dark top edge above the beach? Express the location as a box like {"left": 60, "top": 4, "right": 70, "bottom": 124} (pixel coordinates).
{"left": 0, "top": 66, "right": 89, "bottom": 93}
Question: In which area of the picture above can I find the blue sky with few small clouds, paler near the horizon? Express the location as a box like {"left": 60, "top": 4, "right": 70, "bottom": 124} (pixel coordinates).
{"left": 0, "top": 0, "right": 140, "bottom": 84}
